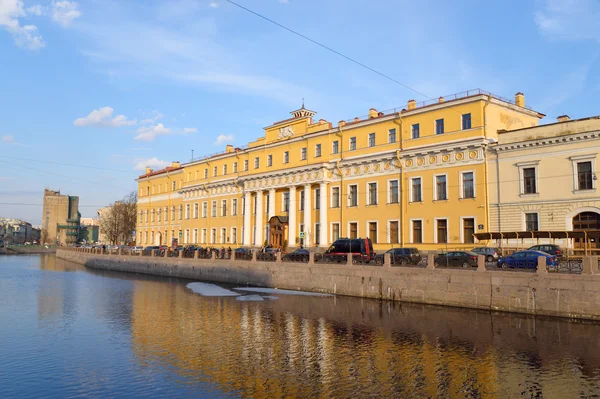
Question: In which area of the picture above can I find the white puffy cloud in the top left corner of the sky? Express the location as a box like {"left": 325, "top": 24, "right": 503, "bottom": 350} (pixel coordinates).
{"left": 0, "top": 0, "right": 46, "bottom": 50}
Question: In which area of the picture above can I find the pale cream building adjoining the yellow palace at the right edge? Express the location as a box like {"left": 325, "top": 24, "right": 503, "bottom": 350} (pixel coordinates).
{"left": 488, "top": 116, "right": 600, "bottom": 253}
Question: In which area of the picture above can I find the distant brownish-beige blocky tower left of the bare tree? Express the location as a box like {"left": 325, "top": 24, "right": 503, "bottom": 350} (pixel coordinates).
{"left": 41, "top": 189, "right": 81, "bottom": 245}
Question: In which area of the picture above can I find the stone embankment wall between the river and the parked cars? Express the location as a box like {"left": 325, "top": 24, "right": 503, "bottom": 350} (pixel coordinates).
{"left": 57, "top": 249, "right": 600, "bottom": 320}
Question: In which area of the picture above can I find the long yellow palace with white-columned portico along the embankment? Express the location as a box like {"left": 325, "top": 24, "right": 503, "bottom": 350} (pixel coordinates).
{"left": 137, "top": 90, "right": 544, "bottom": 250}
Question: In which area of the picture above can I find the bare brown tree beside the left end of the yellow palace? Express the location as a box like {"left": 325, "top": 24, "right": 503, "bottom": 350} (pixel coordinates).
{"left": 100, "top": 192, "right": 137, "bottom": 244}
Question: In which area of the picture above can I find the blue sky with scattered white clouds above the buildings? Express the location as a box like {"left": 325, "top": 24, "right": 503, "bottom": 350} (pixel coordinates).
{"left": 0, "top": 0, "right": 600, "bottom": 224}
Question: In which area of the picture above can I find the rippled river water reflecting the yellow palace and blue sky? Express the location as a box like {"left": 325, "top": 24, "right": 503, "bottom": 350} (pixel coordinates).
{"left": 0, "top": 255, "right": 600, "bottom": 399}
